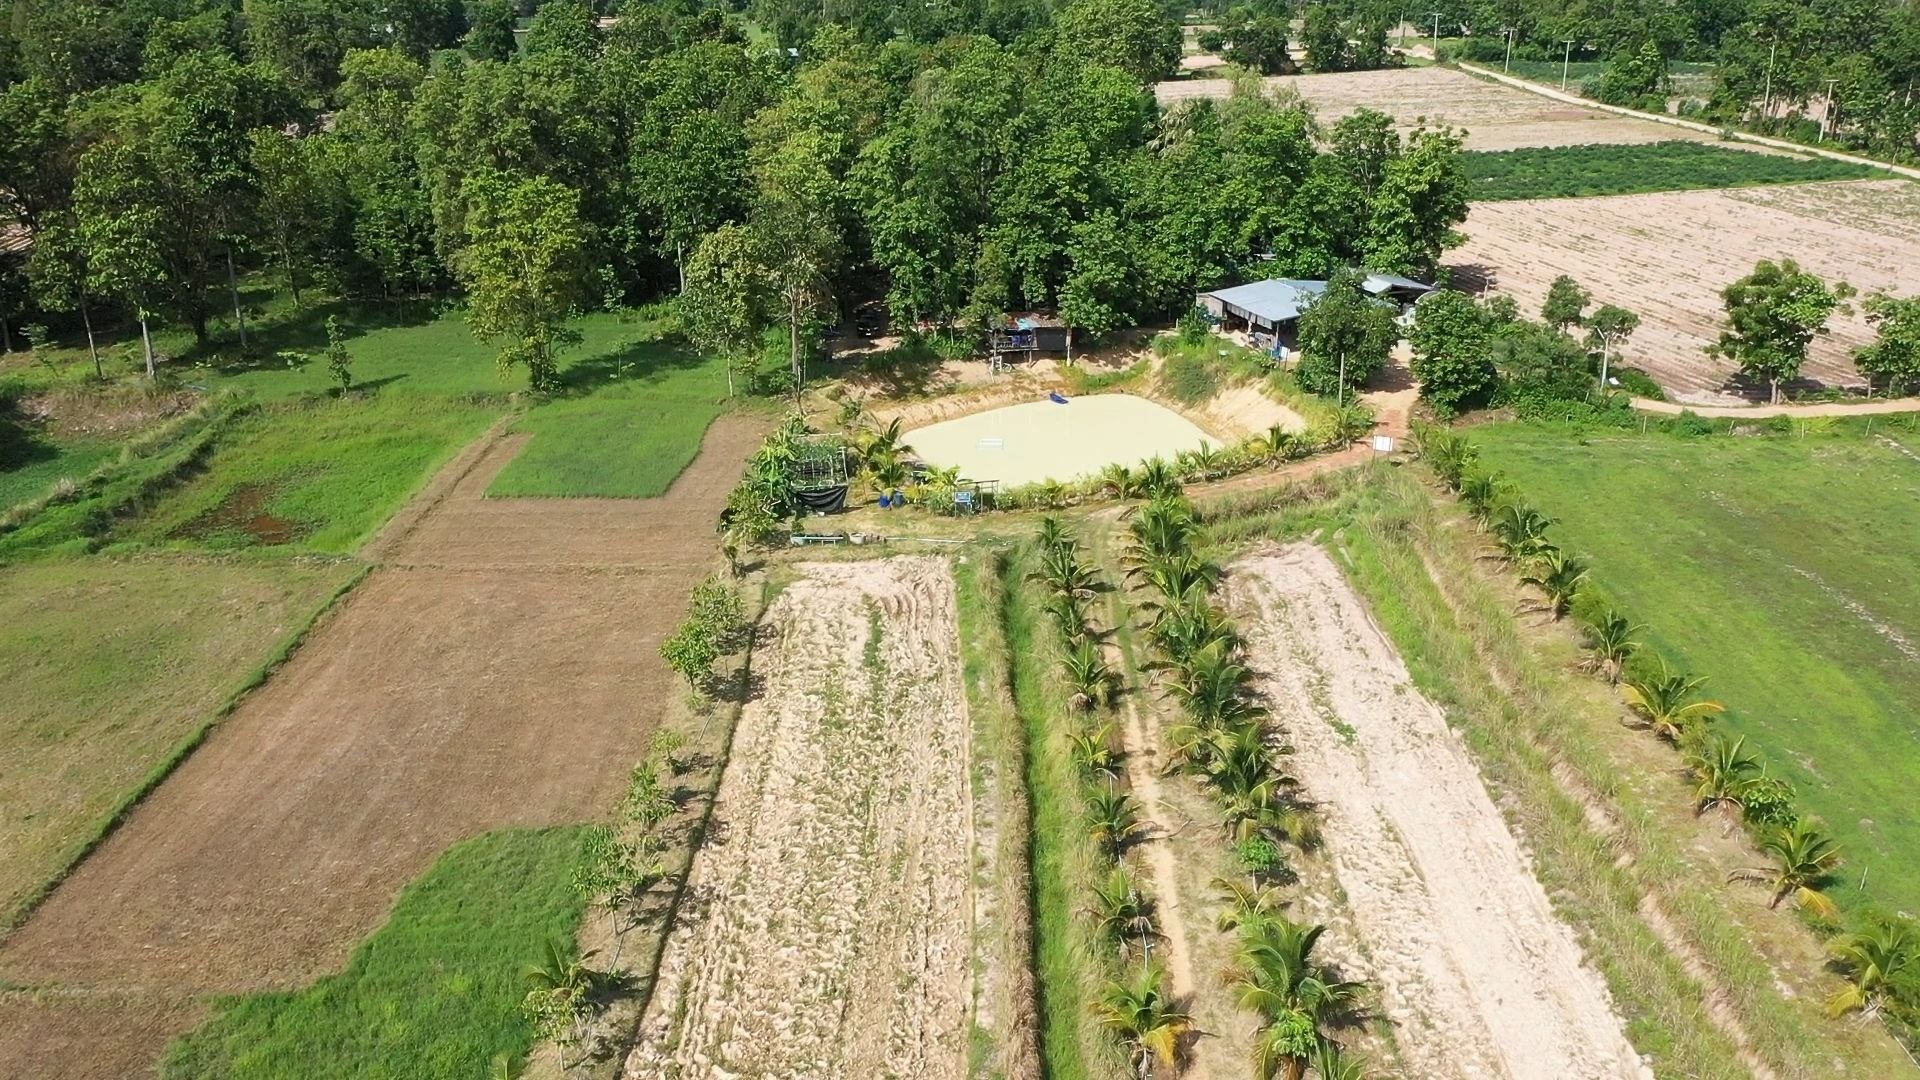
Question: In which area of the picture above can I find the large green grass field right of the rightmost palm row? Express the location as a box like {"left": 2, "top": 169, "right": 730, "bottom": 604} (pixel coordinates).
{"left": 1473, "top": 425, "right": 1920, "bottom": 911}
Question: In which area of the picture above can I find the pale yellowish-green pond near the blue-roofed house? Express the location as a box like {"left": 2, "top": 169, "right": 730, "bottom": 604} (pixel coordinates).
{"left": 906, "top": 394, "right": 1225, "bottom": 486}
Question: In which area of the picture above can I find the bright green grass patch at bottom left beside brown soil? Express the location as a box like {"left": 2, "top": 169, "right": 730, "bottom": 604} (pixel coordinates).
{"left": 161, "top": 826, "right": 589, "bottom": 1080}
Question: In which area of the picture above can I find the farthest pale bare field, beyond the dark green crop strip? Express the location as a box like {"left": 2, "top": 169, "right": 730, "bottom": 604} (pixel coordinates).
{"left": 1154, "top": 67, "right": 1707, "bottom": 150}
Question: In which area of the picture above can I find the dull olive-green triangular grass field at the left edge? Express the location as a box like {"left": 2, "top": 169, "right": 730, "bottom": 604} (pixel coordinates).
{"left": 0, "top": 557, "right": 359, "bottom": 926}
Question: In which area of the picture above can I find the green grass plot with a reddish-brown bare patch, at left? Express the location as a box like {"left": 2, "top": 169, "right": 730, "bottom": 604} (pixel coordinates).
{"left": 115, "top": 394, "right": 501, "bottom": 552}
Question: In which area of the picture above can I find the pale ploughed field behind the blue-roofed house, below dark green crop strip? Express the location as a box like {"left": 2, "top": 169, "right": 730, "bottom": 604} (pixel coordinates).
{"left": 1446, "top": 181, "right": 1920, "bottom": 405}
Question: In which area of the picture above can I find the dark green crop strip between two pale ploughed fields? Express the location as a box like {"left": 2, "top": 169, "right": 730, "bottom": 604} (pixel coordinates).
{"left": 1465, "top": 138, "right": 1874, "bottom": 202}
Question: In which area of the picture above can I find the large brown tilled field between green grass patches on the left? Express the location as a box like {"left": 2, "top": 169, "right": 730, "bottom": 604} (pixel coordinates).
{"left": 0, "top": 409, "right": 760, "bottom": 1076}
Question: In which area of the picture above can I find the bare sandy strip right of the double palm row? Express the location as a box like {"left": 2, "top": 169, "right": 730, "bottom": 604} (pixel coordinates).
{"left": 1229, "top": 544, "right": 1651, "bottom": 1080}
